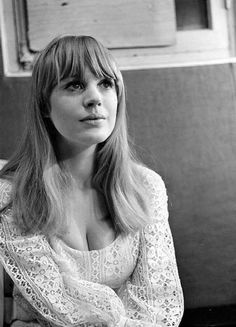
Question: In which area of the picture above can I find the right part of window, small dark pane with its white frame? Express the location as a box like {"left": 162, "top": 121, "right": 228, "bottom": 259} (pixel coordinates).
{"left": 114, "top": 0, "right": 232, "bottom": 68}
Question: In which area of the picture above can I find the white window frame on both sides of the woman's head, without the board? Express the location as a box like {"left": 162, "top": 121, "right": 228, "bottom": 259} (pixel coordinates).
{"left": 0, "top": 0, "right": 236, "bottom": 77}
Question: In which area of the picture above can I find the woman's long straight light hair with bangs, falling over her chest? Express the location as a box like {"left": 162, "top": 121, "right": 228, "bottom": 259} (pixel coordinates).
{"left": 0, "top": 35, "right": 148, "bottom": 235}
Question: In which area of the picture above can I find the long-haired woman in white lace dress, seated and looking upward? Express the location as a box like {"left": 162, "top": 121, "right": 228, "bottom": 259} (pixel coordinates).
{"left": 0, "top": 36, "right": 183, "bottom": 327}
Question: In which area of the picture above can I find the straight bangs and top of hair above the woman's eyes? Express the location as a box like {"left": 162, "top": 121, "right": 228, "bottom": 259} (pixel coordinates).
{"left": 51, "top": 36, "right": 119, "bottom": 93}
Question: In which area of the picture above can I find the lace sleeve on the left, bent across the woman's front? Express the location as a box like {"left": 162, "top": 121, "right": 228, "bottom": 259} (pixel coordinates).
{"left": 0, "top": 209, "right": 129, "bottom": 327}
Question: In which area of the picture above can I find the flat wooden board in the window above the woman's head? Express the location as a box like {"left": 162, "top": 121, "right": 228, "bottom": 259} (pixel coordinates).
{"left": 27, "top": 0, "right": 176, "bottom": 51}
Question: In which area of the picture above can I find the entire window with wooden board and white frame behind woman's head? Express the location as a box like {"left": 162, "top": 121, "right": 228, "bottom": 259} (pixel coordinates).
{"left": 0, "top": 0, "right": 234, "bottom": 76}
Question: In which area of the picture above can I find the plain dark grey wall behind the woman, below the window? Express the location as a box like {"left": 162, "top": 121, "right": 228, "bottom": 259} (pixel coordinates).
{"left": 0, "top": 44, "right": 236, "bottom": 308}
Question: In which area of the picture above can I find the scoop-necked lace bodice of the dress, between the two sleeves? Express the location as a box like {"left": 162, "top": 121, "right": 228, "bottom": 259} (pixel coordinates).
{"left": 50, "top": 233, "right": 139, "bottom": 289}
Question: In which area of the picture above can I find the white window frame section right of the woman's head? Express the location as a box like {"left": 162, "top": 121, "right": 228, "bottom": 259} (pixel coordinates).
{"left": 114, "top": 0, "right": 236, "bottom": 69}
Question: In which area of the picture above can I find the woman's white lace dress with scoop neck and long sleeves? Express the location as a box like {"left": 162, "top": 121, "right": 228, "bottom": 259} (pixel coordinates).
{"left": 0, "top": 169, "right": 183, "bottom": 327}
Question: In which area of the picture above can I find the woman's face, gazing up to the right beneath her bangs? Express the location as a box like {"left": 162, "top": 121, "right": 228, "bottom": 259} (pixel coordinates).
{"left": 50, "top": 68, "right": 118, "bottom": 154}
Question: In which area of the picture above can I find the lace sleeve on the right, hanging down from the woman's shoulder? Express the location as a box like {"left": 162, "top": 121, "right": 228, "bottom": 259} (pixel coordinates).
{"left": 119, "top": 171, "right": 183, "bottom": 327}
